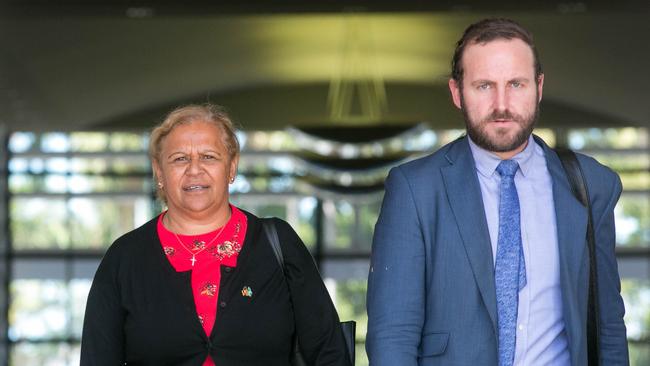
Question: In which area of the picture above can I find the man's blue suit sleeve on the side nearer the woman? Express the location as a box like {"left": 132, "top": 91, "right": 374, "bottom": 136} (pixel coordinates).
{"left": 366, "top": 167, "right": 425, "bottom": 366}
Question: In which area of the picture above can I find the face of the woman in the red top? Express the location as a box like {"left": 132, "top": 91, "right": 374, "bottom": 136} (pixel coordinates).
{"left": 153, "top": 121, "right": 237, "bottom": 218}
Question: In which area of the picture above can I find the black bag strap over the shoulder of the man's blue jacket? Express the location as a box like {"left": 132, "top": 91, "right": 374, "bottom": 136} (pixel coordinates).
{"left": 555, "top": 148, "right": 600, "bottom": 366}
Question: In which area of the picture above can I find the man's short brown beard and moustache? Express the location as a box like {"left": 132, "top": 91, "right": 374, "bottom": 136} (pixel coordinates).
{"left": 461, "top": 91, "right": 539, "bottom": 153}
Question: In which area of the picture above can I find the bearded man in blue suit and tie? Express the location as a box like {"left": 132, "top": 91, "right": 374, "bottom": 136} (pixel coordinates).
{"left": 367, "top": 19, "right": 629, "bottom": 366}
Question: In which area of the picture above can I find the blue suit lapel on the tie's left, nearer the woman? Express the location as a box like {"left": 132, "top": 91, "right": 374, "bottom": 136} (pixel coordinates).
{"left": 441, "top": 137, "right": 497, "bottom": 332}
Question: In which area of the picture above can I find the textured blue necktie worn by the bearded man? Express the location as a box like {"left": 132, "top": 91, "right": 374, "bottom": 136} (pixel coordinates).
{"left": 494, "top": 160, "right": 526, "bottom": 366}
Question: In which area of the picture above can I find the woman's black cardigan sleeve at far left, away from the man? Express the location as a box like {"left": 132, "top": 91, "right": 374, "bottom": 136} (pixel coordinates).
{"left": 80, "top": 249, "right": 124, "bottom": 366}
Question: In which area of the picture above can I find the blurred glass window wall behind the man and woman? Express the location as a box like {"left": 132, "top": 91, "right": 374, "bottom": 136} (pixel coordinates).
{"left": 0, "top": 126, "right": 650, "bottom": 366}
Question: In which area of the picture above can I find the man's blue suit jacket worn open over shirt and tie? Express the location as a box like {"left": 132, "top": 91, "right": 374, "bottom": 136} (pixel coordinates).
{"left": 366, "top": 137, "right": 629, "bottom": 366}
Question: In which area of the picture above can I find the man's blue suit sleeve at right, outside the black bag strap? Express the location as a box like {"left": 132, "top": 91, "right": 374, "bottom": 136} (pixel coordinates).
{"left": 590, "top": 170, "right": 629, "bottom": 365}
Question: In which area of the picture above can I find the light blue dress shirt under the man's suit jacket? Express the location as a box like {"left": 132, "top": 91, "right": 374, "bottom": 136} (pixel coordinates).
{"left": 469, "top": 136, "right": 570, "bottom": 366}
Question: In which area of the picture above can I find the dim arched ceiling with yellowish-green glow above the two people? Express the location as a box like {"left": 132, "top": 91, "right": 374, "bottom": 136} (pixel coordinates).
{"left": 0, "top": 1, "right": 650, "bottom": 130}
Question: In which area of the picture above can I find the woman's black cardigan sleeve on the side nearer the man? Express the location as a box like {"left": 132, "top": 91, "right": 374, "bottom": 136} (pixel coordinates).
{"left": 276, "top": 220, "right": 350, "bottom": 366}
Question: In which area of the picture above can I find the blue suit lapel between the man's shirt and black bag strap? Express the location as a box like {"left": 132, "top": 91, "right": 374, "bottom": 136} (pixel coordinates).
{"left": 536, "top": 138, "right": 587, "bottom": 355}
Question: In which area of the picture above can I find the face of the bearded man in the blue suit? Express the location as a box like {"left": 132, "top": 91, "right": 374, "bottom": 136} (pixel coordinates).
{"left": 449, "top": 39, "right": 544, "bottom": 159}
